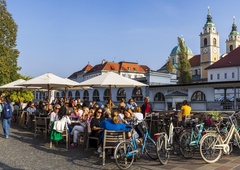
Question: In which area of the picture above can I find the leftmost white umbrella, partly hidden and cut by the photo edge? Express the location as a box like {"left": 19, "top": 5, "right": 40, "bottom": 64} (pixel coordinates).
{"left": 0, "top": 79, "right": 41, "bottom": 90}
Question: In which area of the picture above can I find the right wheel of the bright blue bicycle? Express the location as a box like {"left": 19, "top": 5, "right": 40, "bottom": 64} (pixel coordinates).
{"left": 145, "top": 137, "right": 158, "bottom": 160}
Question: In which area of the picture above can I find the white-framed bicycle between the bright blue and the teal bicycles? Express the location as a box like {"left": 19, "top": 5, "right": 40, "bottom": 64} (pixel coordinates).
{"left": 154, "top": 115, "right": 182, "bottom": 165}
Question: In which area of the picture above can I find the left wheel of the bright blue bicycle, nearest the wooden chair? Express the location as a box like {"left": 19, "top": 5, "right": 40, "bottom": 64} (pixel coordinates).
{"left": 114, "top": 141, "right": 135, "bottom": 169}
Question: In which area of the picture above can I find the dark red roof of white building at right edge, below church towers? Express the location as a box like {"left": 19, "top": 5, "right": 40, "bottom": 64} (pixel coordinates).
{"left": 206, "top": 47, "right": 240, "bottom": 70}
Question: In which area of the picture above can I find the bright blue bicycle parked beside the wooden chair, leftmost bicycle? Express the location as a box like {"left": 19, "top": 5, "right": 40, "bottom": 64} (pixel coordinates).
{"left": 114, "top": 115, "right": 157, "bottom": 169}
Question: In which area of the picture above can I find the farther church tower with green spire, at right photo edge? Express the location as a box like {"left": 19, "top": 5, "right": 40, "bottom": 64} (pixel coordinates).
{"left": 226, "top": 17, "right": 240, "bottom": 53}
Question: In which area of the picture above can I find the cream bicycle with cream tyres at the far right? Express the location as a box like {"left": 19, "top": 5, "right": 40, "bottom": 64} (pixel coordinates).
{"left": 200, "top": 113, "right": 240, "bottom": 163}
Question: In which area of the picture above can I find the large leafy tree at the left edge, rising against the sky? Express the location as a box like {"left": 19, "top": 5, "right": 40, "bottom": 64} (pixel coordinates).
{"left": 0, "top": 0, "right": 21, "bottom": 85}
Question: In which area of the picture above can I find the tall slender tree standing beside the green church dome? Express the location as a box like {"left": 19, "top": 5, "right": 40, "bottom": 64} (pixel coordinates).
{"left": 178, "top": 37, "right": 192, "bottom": 84}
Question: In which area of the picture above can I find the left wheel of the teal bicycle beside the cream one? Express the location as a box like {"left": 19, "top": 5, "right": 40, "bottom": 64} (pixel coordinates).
{"left": 179, "top": 131, "right": 194, "bottom": 159}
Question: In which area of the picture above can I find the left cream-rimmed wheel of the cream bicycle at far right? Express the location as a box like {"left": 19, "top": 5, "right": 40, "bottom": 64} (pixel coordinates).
{"left": 200, "top": 133, "right": 222, "bottom": 163}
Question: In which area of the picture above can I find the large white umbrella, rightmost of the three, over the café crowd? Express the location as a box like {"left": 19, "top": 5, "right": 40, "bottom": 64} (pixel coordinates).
{"left": 79, "top": 72, "right": 147, "bottom": 98}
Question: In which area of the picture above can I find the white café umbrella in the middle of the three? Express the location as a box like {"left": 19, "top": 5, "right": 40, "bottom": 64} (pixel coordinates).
{"left": 16, "top": 73, "right": 83, "bottom": 97}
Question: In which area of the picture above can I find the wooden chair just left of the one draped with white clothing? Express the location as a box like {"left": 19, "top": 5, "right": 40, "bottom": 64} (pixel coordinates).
{"left": 33, "top": 116, "right": 48, "bottom": 141}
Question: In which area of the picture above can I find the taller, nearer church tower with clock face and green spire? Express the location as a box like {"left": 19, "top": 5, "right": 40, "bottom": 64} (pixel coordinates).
{"left": 200, "top": 8, "right": 220, "bottom": 81}
